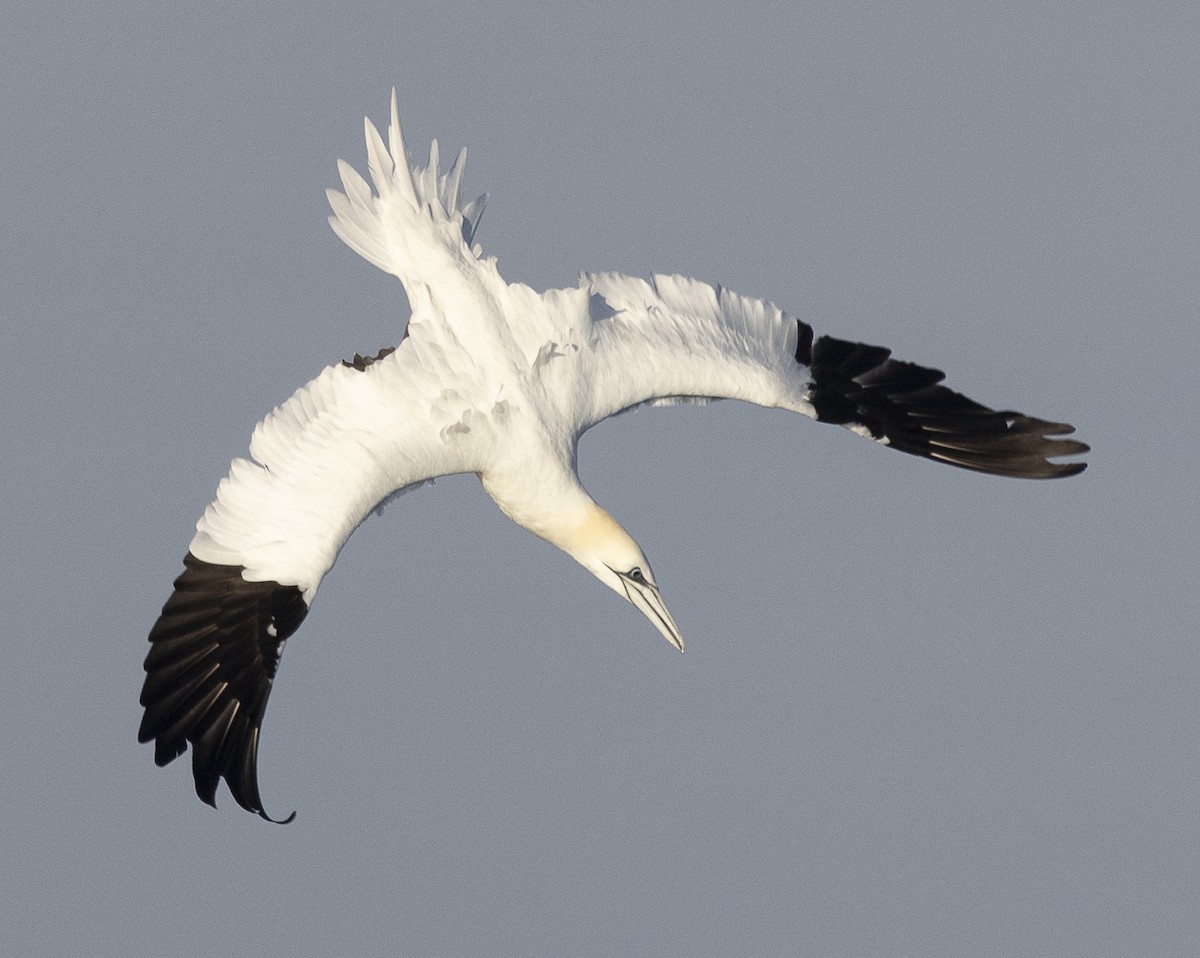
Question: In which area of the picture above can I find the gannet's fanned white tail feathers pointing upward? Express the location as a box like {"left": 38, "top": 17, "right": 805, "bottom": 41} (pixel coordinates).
{"left": 326, "top": 89, "right": 487, "bottom": 285}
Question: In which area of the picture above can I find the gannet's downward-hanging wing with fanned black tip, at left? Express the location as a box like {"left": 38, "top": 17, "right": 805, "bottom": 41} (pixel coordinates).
{"left": 138, "top": 337, "right": 492, "bottom": 818}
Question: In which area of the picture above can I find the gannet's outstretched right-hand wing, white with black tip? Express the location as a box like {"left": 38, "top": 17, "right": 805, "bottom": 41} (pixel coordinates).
{"left": 578, "top": 273, "right": 1087, "bottom": 479}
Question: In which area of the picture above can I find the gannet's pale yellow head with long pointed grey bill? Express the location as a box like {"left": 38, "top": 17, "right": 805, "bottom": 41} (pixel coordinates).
{"left": 560, "top": 507, "right": 683, "bottom": 652}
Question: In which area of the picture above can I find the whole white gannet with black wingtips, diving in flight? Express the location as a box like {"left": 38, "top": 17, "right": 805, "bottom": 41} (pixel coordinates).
{"left": 138, "top": 91, "right": 1087, "bottom": 821}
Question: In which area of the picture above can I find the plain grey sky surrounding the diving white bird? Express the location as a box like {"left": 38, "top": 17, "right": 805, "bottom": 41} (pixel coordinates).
{"left": 0, "top": 2, "right": 1200, "bottom": 958}
